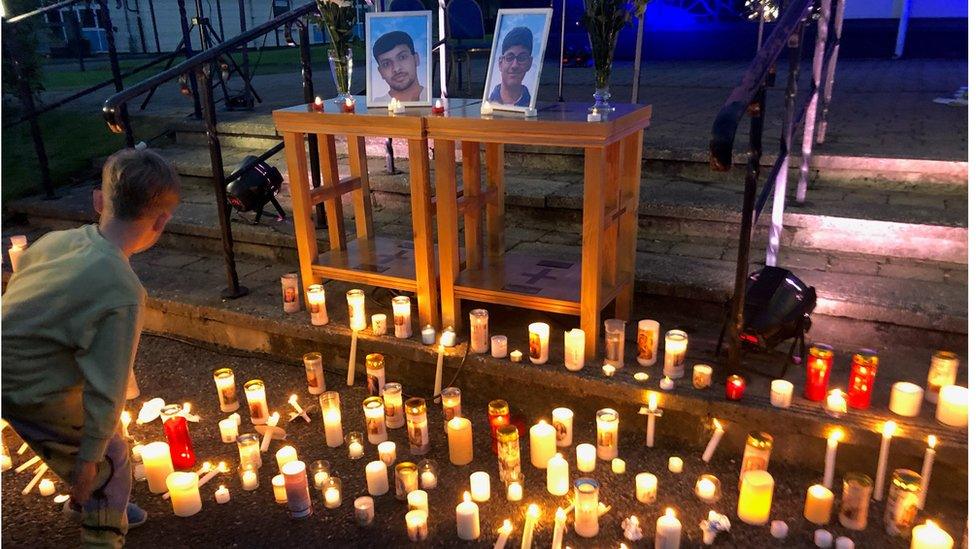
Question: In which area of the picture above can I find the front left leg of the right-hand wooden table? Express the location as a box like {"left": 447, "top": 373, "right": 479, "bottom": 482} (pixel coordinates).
{"left": 434, "top": 139, "right": 461, "bottom": 328}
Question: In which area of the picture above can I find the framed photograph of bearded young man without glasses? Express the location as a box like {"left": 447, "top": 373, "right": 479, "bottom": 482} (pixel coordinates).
{"left": 366, "top": 11, "right": 432, "bottom": 107}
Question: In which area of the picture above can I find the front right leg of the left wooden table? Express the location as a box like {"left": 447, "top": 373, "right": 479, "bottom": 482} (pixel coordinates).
{"left": 407, "top": 139, "right": 440, "bottom": 326}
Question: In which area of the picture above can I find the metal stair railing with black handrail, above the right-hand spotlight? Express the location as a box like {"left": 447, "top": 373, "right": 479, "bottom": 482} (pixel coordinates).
{"left": 709, "top": 0, "right": 845, "bottom": 370}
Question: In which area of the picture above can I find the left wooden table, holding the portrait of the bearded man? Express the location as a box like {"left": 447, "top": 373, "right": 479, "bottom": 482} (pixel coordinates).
{"left": 273, "top": 97, "right": 440, "bottom": 326}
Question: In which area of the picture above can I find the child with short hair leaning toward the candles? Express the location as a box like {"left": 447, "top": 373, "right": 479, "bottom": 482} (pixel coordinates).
{"left": 0, "top": 149, "right": 180, "bottom": 547}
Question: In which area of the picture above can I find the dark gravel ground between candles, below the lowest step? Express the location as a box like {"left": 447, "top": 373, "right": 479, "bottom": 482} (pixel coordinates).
{"left": 2, "top": 335, "right": 966, "bottom": 548}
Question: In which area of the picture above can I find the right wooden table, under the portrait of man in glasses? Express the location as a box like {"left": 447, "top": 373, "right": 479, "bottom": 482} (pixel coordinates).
{"left": 426, "top": 103, "right": 651, "bottom": 359}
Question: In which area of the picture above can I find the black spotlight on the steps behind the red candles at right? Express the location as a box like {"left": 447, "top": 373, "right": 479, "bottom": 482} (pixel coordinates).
{"left": 716, "top": 266, "right": 817, "bottom": 375}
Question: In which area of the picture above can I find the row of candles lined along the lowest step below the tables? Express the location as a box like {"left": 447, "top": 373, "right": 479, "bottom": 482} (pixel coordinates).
{"left": 281, "top": 273, "right": 969, "bottom": 427}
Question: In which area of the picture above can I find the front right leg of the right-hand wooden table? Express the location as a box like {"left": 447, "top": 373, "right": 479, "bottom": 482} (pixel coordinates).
{"left": 580, "top": 147, "right": 607, "bottom": 360}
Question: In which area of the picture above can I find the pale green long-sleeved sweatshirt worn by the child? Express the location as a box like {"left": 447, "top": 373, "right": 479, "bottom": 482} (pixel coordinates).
{"left": 0, "top": 225, "right": 146, "bottom": 461}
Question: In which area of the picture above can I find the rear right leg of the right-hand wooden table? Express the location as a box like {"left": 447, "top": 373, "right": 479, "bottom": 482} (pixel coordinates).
{"left": 614, "top": 130, "right": 644, "bottom": 320}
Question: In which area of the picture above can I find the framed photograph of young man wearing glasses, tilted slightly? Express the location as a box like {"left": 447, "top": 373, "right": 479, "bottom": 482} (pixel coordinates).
{"left": 482, "top": 8, "right": 552, "bottom": 112}
